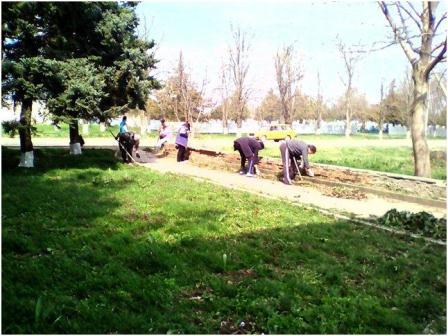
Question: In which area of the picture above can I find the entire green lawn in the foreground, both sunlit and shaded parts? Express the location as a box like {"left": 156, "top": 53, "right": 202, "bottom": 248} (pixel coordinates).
{"left": 2, "top": 149, "right": 446, "bottom": 334}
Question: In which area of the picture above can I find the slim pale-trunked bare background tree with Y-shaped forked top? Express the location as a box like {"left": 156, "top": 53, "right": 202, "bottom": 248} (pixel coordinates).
{"left": 336, "top": 38, "right": 359, "bottom": 137}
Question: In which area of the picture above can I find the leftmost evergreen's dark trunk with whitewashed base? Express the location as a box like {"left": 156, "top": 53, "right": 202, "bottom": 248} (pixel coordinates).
{"left": 19, "top": 99, "right": 34, "bottom": 168}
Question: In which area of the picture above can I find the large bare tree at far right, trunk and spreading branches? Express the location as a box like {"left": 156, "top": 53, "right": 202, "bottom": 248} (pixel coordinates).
{"left": 379, "top": 1, "right": 447, "bottom": 177}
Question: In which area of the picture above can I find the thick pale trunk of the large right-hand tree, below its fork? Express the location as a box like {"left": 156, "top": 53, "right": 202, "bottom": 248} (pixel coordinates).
{"left": 411, "top": 69, "right": 431, "bottom": 177}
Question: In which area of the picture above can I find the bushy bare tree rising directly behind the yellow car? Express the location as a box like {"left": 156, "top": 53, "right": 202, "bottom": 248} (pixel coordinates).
{"left": 275, "top": 45, "right": 303, "bottom": 124}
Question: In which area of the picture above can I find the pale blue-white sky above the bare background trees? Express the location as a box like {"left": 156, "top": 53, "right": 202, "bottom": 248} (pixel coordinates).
{"left": 137, "top": 0, "right": 446, "bottom": 105}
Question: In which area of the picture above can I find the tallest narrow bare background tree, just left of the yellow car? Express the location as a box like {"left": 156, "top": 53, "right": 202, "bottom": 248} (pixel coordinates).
{"left": 229, "top": 26, "right": 250, "bottom": 129}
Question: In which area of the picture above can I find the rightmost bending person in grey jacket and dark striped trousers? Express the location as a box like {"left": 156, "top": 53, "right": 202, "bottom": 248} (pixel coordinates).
{"left": 280, "top": 140, "right": 316, "bottom": 184}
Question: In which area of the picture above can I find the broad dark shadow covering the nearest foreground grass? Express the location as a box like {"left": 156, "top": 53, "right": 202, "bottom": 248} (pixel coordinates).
{"left": 3, "top": 215, "right": 445, "bottom": 334}
